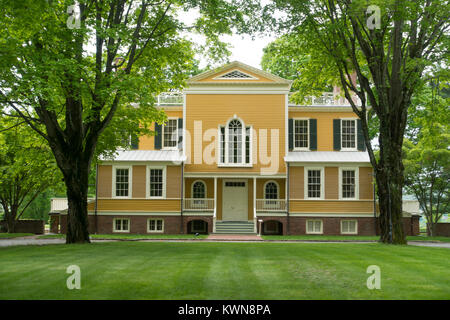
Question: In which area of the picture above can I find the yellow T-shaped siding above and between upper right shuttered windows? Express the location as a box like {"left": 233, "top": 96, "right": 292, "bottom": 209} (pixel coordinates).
{"left": 289, "top": 110, "right": 357, "bottom": 151}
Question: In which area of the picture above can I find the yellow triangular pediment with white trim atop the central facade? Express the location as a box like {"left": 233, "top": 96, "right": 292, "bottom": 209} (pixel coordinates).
{"left": 188, "top": 61, "right": 291, "bottom": 84}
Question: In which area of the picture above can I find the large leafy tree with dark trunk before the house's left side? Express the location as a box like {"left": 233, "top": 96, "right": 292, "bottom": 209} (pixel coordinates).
{"left": 0, "top": 0, "right": 257, "bottom": 243}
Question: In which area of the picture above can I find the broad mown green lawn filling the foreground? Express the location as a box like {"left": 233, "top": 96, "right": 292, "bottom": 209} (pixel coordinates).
{"left": 0, "top": 242, "right": 450, "bottom": 299}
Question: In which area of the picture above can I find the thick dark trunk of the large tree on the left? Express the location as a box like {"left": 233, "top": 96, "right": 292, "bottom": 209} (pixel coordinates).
{"left": 63, "top": 159, "right": 90, "bottom": 244}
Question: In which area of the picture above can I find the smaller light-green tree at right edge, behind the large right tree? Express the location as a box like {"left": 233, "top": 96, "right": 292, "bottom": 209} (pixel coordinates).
{"left": 403, "top": 81, "right": 450, "bottom": 236}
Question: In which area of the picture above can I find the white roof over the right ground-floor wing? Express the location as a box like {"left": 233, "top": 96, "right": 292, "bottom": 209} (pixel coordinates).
{"left": 284, "top": 151, "right": 370, "bottom": 163}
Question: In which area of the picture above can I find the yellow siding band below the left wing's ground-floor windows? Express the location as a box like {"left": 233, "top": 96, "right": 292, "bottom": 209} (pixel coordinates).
{"left": 88, "top": 199, "right": 181, "bottom": 212}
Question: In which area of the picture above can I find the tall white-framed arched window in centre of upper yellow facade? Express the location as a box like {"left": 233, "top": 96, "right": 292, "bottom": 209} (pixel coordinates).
{"left": 219, "top": 119, "right": 251, "bottom": 165}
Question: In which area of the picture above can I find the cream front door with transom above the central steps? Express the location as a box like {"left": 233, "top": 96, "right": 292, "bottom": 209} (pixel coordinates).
{"left": 222, "top": 180, "right": 248, "bottom": 221}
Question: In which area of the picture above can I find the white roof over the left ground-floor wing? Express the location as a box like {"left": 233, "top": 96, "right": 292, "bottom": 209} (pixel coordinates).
{"left": 100, "top": 150, "right": 186, "bottom": 162}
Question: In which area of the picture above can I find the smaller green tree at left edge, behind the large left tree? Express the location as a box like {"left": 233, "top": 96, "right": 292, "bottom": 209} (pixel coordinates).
{"left": 0, "top": 117, "right": 61, "bottom": 233}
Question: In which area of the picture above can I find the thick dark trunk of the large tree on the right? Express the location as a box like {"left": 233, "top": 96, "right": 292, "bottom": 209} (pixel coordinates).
{"left": 375, "top": 132, "right": 406, "bottom": 244}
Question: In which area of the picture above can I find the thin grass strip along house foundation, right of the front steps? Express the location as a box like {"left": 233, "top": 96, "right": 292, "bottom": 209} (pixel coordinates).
{"left": 262, "top": 235, "right": 450, "bottom": 242}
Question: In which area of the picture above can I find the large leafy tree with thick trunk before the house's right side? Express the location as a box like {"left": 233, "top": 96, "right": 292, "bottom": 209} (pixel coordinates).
{"left": 273, "top": 0, "right": 450, "bottom": 244}
